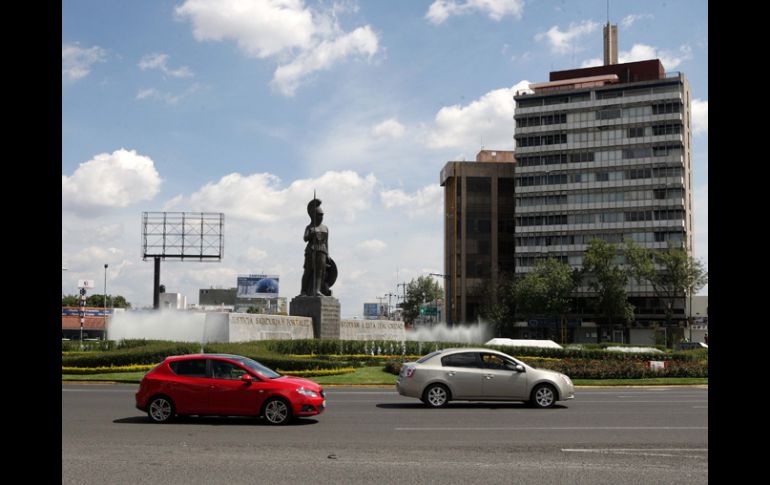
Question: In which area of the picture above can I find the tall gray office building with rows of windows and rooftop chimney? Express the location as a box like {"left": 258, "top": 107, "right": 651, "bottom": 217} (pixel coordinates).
{"left": 514, "top": 26, "right": 693, "bottom": 342}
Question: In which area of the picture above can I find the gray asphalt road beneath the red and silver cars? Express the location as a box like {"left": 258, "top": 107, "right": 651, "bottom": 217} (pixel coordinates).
{"left": 62, "top": 384, "right": 708, "bottom": 485}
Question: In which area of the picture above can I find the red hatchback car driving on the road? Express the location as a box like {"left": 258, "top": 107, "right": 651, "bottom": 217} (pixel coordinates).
{"left": 136, "top": 354, "right": 326, "bottom": 424}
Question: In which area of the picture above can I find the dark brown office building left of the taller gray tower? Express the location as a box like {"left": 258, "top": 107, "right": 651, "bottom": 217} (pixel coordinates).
{"left": 441, "top": 150, "right": 516, "bottom": 324}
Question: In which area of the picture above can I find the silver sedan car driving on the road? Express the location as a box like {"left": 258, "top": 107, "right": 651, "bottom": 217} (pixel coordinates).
{"left": 396, "top": 348, "right": 575, "bottom": 408}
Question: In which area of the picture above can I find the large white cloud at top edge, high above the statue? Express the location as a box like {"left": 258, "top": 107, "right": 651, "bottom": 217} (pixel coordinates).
{"left": 176, "top": 0, "right": 379, "bottom": 96}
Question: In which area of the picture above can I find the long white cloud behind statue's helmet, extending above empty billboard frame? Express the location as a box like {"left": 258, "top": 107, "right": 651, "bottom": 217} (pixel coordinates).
{"left": 164, "top": 171, "right": 377, "bottom": 222}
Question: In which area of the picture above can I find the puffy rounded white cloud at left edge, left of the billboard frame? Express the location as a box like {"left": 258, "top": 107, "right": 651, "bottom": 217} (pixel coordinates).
{"left": 62, "top": 148, "right": 161, "bottom": 214}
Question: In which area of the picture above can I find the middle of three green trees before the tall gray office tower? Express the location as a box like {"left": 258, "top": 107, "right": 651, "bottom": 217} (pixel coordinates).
{"left": 582, "top": 239, "right": 634, "bottom": 325}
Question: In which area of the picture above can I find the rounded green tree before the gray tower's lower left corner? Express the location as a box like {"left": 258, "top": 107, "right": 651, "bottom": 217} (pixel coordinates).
{"left": 514, "top": 258, "right": 579, "bottom": 343}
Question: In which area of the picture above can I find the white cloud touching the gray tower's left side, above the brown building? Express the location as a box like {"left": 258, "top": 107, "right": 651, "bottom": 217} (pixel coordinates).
{"left": 424, "top": 81, "right": 529, "bottom": 150}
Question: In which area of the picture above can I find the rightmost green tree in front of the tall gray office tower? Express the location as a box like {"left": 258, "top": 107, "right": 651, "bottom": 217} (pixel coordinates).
{"left": 626, "top": 242, "right": 708, "bottom": 325}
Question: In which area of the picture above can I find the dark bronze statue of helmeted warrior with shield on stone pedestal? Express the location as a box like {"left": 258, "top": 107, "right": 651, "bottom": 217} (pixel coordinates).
{"left": 301, "top": 198, "right": 337, "bottom": 296}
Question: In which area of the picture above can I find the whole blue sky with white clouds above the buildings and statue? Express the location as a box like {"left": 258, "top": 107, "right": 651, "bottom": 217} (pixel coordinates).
{"left": 62, "top": 0, "right": 708, "bottom": 316}
